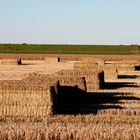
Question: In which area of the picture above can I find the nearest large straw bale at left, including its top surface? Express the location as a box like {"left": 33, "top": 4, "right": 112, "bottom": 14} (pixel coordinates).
{"left": 0, "top": 79, "right": 56, "bottom": 118}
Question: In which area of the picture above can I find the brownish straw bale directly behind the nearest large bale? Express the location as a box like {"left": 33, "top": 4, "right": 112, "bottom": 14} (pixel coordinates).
{"left": 24, "top": 70, "right": 85, "bottom": 90}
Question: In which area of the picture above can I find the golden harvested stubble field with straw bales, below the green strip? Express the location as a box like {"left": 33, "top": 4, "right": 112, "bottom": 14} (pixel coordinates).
{"left": 0, "top": 54, "right": 140, "bottom": 140}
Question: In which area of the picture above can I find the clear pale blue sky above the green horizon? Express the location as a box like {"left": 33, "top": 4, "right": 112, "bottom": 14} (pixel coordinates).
{"left": 0, "top": 0, "right": 140, "bottom": 44}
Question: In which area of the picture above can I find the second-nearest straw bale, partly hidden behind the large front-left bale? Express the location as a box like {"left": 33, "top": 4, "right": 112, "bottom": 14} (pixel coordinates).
{"left": 22, "top": 74, "right": 86, "bottom": 90}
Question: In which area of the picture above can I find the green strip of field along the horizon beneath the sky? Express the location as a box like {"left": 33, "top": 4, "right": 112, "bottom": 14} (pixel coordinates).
{"left": 0, "top": 43, "right": 140, "bottom": 55}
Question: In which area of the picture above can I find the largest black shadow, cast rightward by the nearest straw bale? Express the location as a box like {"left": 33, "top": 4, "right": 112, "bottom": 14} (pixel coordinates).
{"left": 52, "top": 86, "right": 140, "bottom": 115}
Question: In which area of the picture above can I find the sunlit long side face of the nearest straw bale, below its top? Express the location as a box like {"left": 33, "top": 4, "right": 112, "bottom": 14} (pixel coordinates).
{"left": 0, "top": 90, "right": 52, "bottom": 117}
